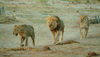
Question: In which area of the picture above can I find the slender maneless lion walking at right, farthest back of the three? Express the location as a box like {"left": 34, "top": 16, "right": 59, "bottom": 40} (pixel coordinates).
{"left": 79, "top": 16, "right": 89, "bottom": 39}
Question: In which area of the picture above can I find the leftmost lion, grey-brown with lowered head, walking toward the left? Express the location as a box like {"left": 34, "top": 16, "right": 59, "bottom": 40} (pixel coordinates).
{"left": 13, "top": 24, "right": 35, "bottom": 47}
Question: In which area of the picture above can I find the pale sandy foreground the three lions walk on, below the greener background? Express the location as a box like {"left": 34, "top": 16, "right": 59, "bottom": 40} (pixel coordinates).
{"left": 0, "top": 23, "right": 100, "bottom": 57}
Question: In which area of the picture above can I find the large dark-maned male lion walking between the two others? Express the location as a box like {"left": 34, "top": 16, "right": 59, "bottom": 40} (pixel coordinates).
{"left": 47, "top": 16, "right": 64, "bottom": 44}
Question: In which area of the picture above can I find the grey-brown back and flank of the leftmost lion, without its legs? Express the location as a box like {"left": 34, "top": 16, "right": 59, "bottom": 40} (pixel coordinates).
{"left": 14, "top": 24, "right": 34, "bottom": 36}
